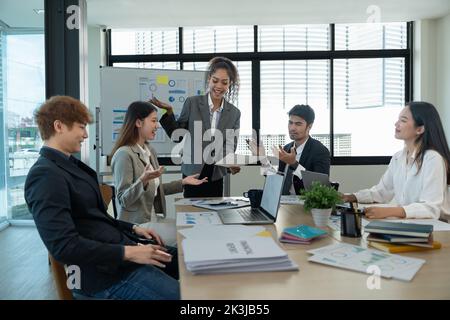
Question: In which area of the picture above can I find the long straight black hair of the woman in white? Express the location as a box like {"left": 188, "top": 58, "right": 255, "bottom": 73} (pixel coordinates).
{"left": 407, "top": 101, "right": 450, "bottom": 184}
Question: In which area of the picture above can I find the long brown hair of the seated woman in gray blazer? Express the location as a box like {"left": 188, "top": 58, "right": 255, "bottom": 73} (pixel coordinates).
{"left": 111, "top": 101, "right": 158, "bottom": 157}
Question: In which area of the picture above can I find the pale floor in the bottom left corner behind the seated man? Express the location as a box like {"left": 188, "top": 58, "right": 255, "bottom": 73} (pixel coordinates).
{"left": 0, "top": 227, "right": 58, "bottom": 300}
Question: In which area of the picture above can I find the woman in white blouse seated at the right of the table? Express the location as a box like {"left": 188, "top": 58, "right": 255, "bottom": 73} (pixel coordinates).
{"left": 343, "top": 102, "right": 450, "bottom": 219}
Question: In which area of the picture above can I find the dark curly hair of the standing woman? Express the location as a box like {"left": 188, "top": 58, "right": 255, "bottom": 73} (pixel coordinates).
{"left": 206, "top": 57, "right": 240, "bottom": 103}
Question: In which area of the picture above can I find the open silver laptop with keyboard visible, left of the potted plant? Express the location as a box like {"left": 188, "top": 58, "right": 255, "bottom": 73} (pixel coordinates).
{"left": 218, "top": 173, "right": 284, "bottom": 224}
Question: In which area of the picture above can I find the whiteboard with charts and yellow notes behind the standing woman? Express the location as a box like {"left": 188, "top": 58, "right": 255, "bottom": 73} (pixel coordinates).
{"left": 99, "top": 67, "right": 206, "bottom": 155}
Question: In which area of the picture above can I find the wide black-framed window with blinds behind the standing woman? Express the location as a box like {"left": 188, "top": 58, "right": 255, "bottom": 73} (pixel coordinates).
{"left": 110, "top": 22, "right": 410, "bottom": 157}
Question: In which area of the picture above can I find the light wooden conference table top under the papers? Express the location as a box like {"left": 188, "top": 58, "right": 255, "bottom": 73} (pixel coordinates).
{"left": 176, "top": 205, "right": 450, "bottom": 300}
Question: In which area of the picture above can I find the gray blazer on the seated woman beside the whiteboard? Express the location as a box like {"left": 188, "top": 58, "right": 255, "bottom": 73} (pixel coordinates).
{"left": 111, "top": 143, "right": 183, "bottom": 224}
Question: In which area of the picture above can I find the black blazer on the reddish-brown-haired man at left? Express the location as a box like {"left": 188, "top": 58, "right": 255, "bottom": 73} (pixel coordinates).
{"left": 25, "top": 147, "right": 139, "bottom": 293}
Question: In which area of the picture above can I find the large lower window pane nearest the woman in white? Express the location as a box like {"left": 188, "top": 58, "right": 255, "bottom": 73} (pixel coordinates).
{"left": 334, "top": 58, "right": 405, "bottom": 156}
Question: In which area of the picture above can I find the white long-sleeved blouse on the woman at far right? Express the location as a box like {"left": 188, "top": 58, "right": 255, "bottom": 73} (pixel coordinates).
{"left": 355, "top": 149, "right": 450, "bottom": 219}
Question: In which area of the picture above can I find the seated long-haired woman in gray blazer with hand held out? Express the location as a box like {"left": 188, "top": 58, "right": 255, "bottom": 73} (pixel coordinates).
{"left": 111, "top": 101, "right": 207, "bottom": 224}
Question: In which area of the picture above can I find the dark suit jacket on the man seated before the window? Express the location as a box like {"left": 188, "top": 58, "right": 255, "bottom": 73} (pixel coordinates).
{"left": 278, "top": 137, "right": 330, "bottom": 194}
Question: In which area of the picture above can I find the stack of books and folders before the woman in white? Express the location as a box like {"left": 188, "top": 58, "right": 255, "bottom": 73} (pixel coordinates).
{"left": 365, "top": 221, "right": 441, "bottom": 253}
